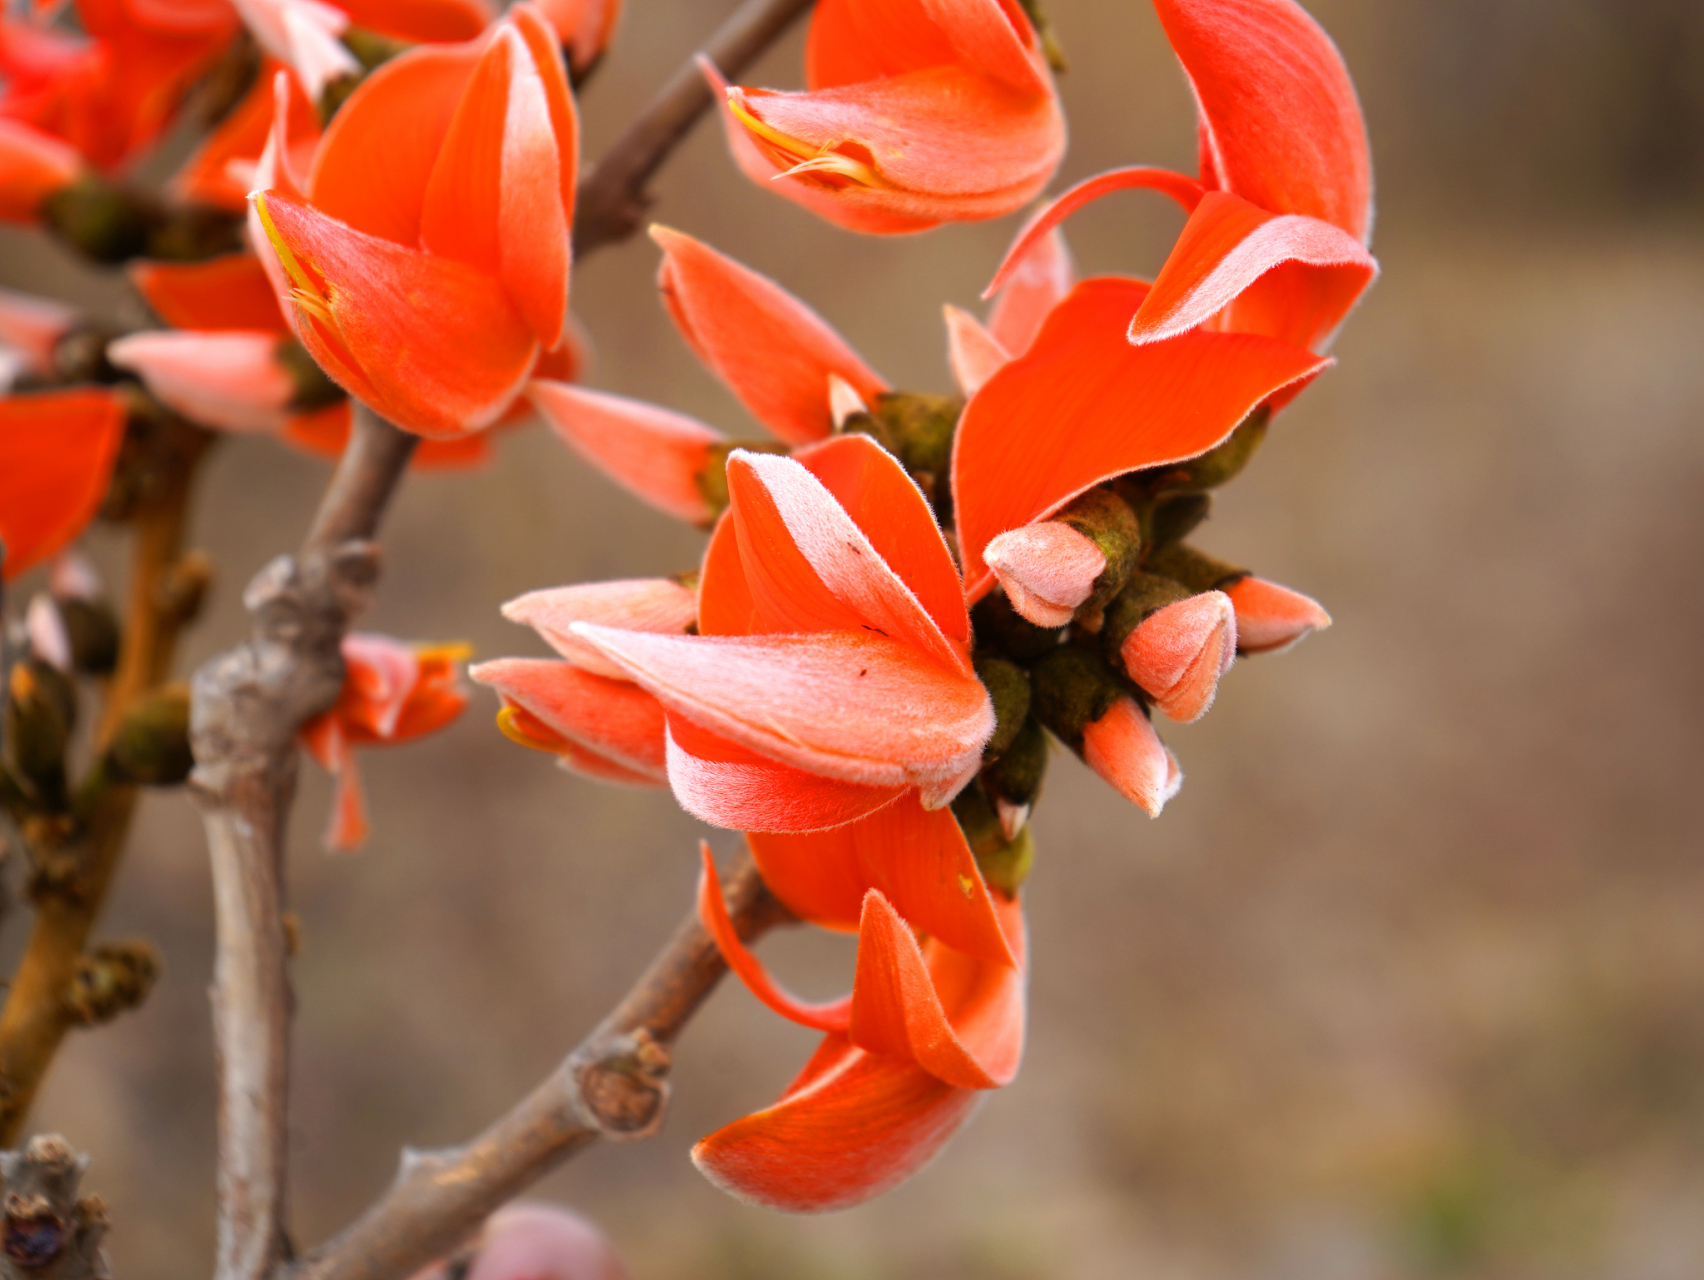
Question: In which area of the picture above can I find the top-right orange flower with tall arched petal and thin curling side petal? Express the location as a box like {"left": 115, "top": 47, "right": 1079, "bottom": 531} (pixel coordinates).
{"left": 988, "top": 0, "right": 1379, "bottom": 349}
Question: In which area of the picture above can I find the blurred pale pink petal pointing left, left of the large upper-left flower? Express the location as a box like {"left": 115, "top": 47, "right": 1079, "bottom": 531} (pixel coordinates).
{"left": 107, "top": 329, "right": 296, "bottom": 431}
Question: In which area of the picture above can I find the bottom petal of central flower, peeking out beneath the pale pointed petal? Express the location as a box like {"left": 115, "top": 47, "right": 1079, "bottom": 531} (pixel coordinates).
{"left": 666, "top": 716, "right": 905, "bottom": 833}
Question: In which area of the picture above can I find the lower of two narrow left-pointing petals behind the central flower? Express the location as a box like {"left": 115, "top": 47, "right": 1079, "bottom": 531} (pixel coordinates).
{"left": 469, "top": 658, "right": 665, "bottom": 782}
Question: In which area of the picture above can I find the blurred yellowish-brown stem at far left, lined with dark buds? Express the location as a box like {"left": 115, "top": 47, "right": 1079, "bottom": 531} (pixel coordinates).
{"left": 0, "top": 415, "right": 213, "bottom": 1147}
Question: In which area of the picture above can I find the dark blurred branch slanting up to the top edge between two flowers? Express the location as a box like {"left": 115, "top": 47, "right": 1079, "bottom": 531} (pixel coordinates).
{"left": 574, "top": 0, "right": 811, "bottom": 257}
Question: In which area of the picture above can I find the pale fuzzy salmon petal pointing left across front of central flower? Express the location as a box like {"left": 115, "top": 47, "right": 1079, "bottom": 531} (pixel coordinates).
{"left": 573, "top": 622, "right": 993, "bottom": 803}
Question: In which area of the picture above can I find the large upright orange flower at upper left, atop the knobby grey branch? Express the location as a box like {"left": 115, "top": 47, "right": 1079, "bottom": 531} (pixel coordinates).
{"left": 254, "top": 3, "right": 578, "bottom": 438}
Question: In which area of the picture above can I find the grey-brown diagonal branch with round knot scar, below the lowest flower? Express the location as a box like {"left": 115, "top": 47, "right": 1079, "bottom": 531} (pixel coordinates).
{"left": 281, "top": 857, "right": 792, "bottom": 1280}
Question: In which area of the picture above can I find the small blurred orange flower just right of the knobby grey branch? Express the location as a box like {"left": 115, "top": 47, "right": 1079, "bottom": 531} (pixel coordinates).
{"left": 300, "top": 632, "right": 469, "bottom": 852}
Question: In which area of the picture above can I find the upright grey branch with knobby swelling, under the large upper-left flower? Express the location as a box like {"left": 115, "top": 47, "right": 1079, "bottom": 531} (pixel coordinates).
{"left": 191, "top": 409, "right": 417, "bottom": 1280}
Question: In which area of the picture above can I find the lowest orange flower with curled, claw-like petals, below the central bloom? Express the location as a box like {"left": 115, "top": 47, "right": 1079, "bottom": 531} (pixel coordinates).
{"left": 692, "top": 849, "right": 1026, "bottom": 1214}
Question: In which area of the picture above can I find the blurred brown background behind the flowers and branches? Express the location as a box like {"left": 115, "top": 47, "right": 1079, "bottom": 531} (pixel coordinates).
{"left": 0, "top": 0, "right": 1704, "bottom": 1280}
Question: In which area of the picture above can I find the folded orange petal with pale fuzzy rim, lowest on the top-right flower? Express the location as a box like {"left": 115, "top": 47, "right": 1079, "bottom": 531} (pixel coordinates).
{"left": 1130, "top": 191, "right": 1379, "bottom": 349}
